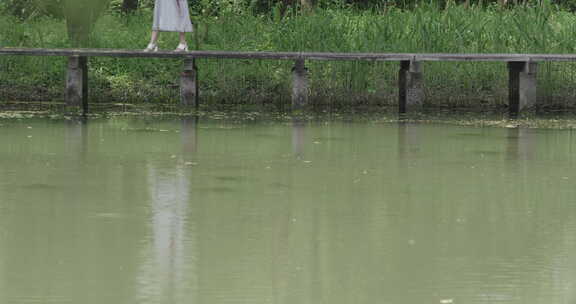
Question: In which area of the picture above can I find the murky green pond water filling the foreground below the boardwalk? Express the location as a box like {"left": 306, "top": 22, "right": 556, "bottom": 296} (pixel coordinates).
{"left": 0, "top": 117, "right": 576, "bottom": 304}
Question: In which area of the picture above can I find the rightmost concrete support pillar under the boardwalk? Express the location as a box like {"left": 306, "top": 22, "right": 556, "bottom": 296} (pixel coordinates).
{"left": 508, "top": 61, "right": 538, "bottom": 117}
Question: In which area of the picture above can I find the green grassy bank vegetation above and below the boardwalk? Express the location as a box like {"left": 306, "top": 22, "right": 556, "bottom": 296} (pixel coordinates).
{"left": 0, "top": 0, "right": 576, "bottom": 107}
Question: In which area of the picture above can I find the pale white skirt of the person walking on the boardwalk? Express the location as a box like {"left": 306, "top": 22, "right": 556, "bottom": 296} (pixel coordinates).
{"left": 152, "top": 0, "right": 192, "bottom": 33}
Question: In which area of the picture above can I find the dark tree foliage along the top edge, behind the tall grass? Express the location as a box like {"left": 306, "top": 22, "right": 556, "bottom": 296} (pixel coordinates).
{"left": 0, "top": 0, "right": 576, "bottom": 20}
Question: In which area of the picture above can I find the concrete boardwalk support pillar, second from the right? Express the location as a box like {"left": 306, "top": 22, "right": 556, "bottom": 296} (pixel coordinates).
{"left": 398, "top": 61, "right": 424, "bottom": 113}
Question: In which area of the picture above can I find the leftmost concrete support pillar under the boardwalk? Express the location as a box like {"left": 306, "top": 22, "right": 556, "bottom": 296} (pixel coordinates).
{"left": 66, "top": 56, "right": 88, "bottom": 114}
